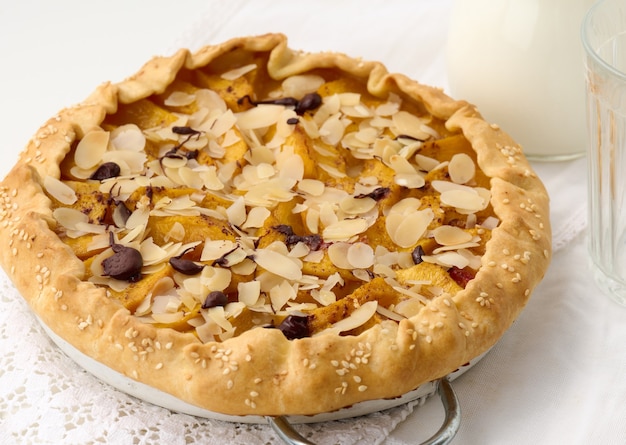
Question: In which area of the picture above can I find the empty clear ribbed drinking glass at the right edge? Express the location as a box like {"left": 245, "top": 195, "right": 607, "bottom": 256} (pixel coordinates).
{"left": 582, "top": 0, "right": 626, "bottom": 305}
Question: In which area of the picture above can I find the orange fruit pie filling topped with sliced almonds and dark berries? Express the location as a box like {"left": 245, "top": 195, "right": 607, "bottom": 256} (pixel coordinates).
{"left": 43, "top": 54, "right": 499, "bottom": 342}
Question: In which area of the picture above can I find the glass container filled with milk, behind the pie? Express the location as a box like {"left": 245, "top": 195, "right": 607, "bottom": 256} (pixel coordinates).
{"left": 447, "top": 0, "right": 593, "bottom": 161}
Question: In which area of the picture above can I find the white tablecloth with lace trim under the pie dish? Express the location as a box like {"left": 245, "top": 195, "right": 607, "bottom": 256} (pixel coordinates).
{"left": 0, "top": 0, "right": 626, "bottom": 444}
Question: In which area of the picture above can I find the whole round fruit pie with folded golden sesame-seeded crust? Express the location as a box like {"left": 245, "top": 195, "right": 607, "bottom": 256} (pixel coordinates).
{"left": 0, "top": 34, "right": 551, "bottom": 415}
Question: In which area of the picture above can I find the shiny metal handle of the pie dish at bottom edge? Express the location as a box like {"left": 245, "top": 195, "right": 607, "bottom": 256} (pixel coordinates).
{"left": 266, "top": 377, "right": 461, "bottom": 445}
